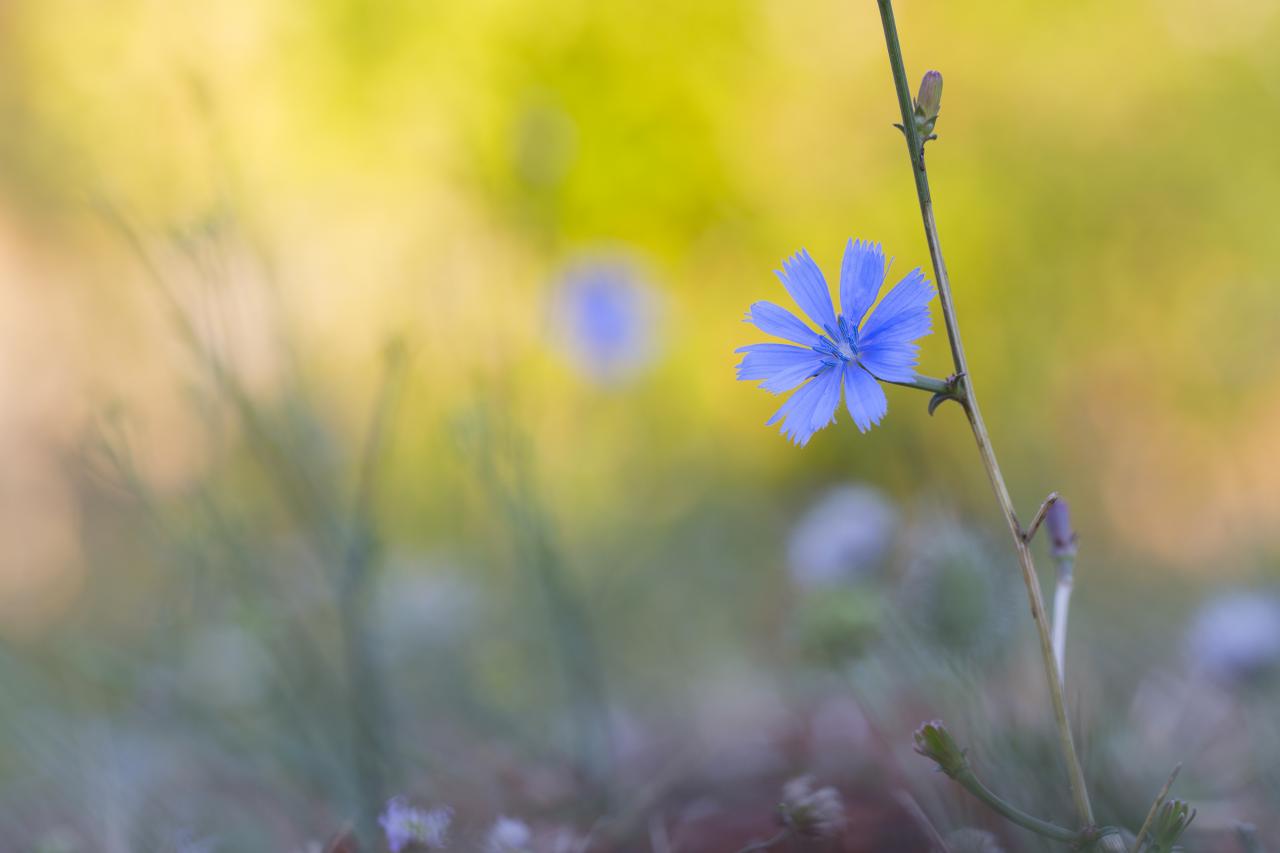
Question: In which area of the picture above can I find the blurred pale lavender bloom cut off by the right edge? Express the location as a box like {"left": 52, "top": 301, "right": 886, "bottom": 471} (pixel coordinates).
{"left": 1188, "top": 592, "right": 1280, "bottom": 684}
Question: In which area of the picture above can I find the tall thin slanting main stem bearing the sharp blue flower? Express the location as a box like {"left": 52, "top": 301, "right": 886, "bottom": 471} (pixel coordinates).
{"left": 877, "top": 0, "right": 1093, "bottom": 826}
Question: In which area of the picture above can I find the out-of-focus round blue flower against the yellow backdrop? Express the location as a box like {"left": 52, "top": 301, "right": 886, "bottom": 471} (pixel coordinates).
{"left": 552, "top": 260, "right": 657, "bottom": 384}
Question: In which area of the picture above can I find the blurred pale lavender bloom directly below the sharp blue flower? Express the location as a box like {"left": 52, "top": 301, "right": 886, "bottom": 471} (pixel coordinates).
{"left": 787, "top": 484, "right": 897, "bottom": 590}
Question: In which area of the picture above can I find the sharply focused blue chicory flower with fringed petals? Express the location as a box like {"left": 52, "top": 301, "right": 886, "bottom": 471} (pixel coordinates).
{"left": 737, "top": 240, "right": 933, "bottom": 447}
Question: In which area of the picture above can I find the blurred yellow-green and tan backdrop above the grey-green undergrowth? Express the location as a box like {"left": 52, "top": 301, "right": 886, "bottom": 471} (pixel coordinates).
{"left": 0, "top": 0, "right": 1280, "bottom": 631}
